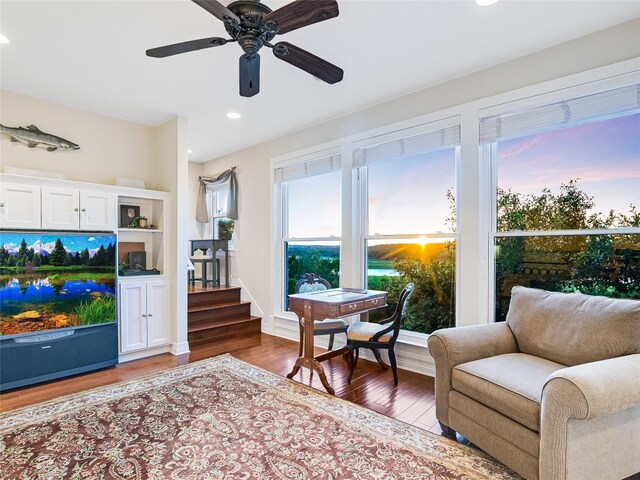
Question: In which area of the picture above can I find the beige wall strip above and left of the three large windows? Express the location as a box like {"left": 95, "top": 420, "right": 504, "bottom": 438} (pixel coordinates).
{"left": 199, "top": 20, "right": 640, "bottom": 324}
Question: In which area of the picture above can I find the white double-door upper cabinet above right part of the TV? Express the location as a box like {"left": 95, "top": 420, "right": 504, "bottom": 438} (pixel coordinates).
{"left": 42, "top": 187, "right": 116, "bottom": 231}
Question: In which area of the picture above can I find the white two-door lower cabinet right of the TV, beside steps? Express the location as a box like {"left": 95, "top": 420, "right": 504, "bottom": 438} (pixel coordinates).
{"left": 119, "top": 279, "right": 171, "bottom": 353}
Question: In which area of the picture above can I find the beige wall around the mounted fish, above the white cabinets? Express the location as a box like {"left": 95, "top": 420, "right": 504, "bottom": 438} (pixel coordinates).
{"left": 0, "top": 91, "right": 163, "bottom": 190}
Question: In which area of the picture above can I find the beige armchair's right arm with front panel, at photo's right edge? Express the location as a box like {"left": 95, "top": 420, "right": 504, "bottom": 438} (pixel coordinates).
{"left": 540, "top": 354, "right": 640, "bottom": 480}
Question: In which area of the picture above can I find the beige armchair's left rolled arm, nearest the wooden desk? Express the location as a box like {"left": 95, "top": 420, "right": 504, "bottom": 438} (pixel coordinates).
{"left": 427, "top": 322, "right": 518, "bottom": 426}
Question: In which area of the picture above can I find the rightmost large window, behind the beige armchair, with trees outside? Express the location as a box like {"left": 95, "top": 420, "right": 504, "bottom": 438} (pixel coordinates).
{"left": 480, "top": 79, "right": 640, "bottom": 320}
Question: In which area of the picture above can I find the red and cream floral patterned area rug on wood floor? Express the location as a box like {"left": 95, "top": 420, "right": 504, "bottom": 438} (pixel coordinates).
{"left": 0, "top": 355, "right": 518, "bottom": 480}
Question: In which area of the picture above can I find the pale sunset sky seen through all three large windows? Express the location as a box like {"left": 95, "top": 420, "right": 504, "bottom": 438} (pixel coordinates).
{"left": 289, "top": 114, "right": 640, "bottom": 238}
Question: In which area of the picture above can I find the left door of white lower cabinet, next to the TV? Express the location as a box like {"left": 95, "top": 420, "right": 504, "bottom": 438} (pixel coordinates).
{"left": 119, "top": 282, "right": 147, "bottom": 353}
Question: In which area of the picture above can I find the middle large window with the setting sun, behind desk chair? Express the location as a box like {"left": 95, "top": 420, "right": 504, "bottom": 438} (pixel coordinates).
{"left": 353, "top": 118, "right": 460, "bottom": 333}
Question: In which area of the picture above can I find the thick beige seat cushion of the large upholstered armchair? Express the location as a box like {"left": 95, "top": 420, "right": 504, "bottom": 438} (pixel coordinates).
{"left": 451, "top": 353, "right": 565, "bottom": 432}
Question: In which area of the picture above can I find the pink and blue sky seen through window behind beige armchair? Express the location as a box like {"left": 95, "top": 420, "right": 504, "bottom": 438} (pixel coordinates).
{"left": 498, "top": 114, "right": 640, "bottom": 217}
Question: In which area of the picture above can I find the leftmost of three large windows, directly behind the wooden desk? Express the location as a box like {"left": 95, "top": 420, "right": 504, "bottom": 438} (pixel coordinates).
{"left": 274, "top": 154, "right": 342, "bottom": 310}
